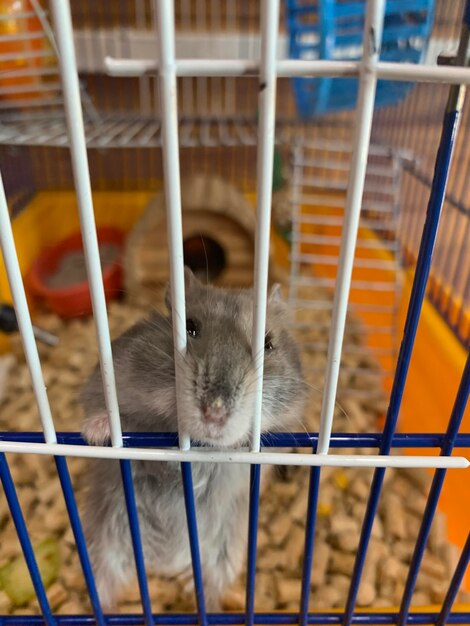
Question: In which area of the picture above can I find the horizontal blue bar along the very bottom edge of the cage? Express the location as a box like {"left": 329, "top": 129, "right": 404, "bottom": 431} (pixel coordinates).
{"left": 0, "top": 612, "right": 470, "bottom": 626}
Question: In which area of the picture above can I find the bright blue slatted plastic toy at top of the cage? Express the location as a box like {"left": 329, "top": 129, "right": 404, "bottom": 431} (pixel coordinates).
{"left": 286, "top": 0, "right": 435, "bottom": 119}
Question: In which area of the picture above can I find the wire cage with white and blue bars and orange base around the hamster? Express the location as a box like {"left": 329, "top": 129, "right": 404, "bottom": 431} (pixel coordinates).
{"left": 0, "top": 0, "right": 470, "bottom": 625}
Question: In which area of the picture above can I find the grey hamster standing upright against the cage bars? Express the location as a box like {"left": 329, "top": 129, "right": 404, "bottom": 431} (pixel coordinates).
{"left": 81, "top": 269, "right": 306, "bottom": 611}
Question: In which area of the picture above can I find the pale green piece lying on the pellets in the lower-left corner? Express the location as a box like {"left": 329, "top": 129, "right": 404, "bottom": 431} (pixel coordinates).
{"left": 0, "top": 539, "right": 60, "bottom": 607}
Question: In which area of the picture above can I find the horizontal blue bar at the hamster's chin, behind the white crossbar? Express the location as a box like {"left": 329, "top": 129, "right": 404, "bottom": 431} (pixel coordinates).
{"left": 0, "top": 432, "right": 470, "bottom": 448}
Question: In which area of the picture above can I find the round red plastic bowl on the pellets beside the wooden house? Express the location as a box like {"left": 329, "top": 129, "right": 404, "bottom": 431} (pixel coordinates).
{"left": 26, "top": 227, "right": 125, "bottom": 319}
